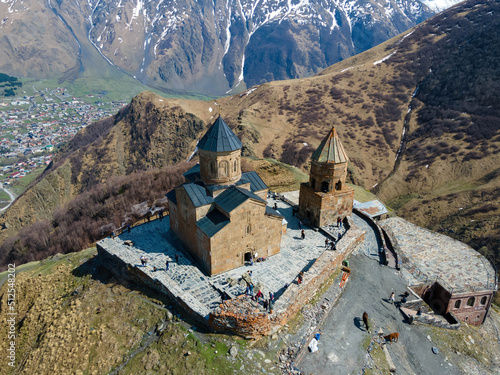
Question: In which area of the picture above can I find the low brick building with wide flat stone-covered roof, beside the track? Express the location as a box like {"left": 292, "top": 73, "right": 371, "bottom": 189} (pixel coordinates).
{"left": 378, "top": 217, "right": 498, "bottom": 325}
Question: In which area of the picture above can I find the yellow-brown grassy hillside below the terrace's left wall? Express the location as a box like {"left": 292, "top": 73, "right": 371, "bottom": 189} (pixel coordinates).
{"left": 0, "top": 248, "right": 278, "bottom": 375}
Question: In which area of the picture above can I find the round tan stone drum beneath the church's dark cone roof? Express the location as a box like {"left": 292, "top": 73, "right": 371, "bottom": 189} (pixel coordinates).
{"left": 200, "top": 149, "right": 241, "bottom": 185}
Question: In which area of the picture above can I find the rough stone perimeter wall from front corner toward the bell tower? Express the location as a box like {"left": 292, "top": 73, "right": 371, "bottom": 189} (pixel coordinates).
{"left": 209, "top": 218, "right": 365, "bottom": 338}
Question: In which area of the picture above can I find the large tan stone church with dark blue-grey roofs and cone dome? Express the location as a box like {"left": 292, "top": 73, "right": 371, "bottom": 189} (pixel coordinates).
{"left": 167, "top": 116, "right": 286, "bottom": 275}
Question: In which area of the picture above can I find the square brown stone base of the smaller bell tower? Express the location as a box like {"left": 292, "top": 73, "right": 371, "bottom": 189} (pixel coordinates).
{"left": 299, "top": 183, "right": 354, "bottom": 227}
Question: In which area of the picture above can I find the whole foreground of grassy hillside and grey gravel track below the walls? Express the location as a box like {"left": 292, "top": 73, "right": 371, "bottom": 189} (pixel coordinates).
{"left": 0, "top": 213, "right": 500, "bottom": 375}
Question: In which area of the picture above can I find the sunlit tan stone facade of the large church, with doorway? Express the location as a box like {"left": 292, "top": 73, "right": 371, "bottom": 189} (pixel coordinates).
{"left": 210, "top": 200, "right": 282, "bottom": 274}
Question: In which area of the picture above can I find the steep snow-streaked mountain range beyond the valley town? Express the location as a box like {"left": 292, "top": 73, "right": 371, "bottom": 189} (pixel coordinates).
{"left": 0, "top": 0, "right": 450, "bottom": 95}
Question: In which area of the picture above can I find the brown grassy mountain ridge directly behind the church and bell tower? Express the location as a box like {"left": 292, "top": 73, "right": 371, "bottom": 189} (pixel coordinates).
{"left": 2, "top": 1, "right": 500, "bottom": 270}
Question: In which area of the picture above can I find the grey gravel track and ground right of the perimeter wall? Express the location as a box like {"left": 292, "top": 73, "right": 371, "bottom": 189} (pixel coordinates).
{"left": 283, "top": 217, "right": 500, "bottom": 375}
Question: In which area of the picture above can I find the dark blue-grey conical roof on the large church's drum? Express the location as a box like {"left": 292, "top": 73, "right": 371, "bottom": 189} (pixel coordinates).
{"left": 198, "top": 116, "right": 243, "bottom": 152}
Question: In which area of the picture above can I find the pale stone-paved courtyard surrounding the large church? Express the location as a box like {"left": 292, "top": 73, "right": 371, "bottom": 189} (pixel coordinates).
{"left": 98, "top": 198, "right": 345, "bottom": 318}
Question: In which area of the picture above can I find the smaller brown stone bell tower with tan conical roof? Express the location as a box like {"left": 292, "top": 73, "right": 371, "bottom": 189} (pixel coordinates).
{"left": 299, "top": 128, "right": 354, "bottom": 227}
